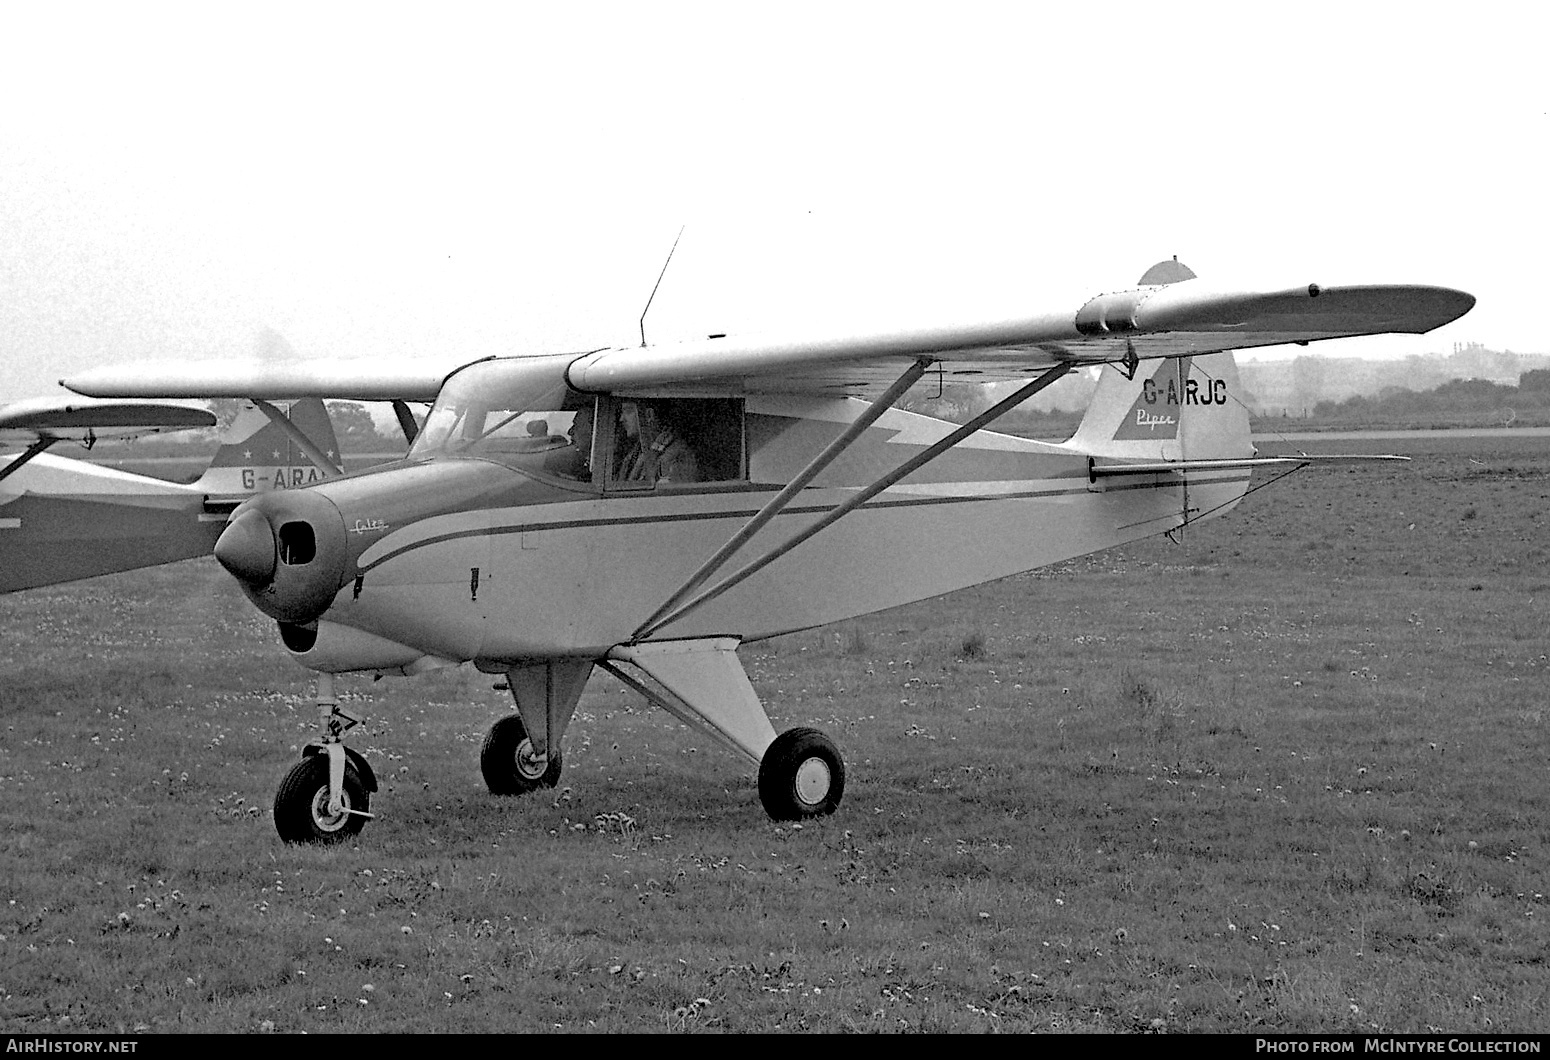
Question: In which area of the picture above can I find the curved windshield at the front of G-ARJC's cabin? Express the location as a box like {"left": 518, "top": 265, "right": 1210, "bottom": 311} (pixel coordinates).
{"left": 408, "top": 355, "right": 592, "bottom": 477}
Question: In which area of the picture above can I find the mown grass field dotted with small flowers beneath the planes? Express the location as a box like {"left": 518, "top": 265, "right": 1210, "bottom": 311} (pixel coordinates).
{"left": 0, "top": 440, "right": 1550, "bottom": 1032}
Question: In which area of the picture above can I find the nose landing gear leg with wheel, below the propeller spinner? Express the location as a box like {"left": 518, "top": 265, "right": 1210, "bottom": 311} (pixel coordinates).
{"left": 274, "top": 674, "right": 377, "bottom": 843}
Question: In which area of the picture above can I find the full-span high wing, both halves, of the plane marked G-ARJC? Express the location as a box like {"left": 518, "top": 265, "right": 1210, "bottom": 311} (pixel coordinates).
{"left": 62, "top": 271, "right": 1474, "bottom": 401}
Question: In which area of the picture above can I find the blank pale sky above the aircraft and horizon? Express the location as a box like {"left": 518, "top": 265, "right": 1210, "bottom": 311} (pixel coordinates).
{"left": 0, "top": 0, "right": 1550, "bottom": 400}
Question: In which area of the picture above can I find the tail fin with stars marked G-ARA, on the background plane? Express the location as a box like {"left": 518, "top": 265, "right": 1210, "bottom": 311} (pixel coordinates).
{"left": 194, "top": 398, "right": 339, "bottom": 499}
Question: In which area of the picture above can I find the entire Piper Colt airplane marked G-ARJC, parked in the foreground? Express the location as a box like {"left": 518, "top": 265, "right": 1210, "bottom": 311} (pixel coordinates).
{"left": 65, "top": 260, "right": 1474, "bottom": 841}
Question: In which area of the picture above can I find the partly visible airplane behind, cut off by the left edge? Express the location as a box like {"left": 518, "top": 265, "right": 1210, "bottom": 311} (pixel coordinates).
{"left": 0, "top": 398, "right": 339, "bottom": 592}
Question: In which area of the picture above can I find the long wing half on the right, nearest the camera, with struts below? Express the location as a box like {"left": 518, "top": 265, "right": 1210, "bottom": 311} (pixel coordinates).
{"left": 567, "top": 280, "right": 1474, "bottom": 395}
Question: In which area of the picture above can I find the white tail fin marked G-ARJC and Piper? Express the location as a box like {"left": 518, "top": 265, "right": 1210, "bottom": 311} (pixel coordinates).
{"left": 1068, "top": 352, "right": 1254, "bottom": 460}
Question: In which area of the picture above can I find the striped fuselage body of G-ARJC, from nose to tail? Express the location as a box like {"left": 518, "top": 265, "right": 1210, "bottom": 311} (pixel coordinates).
{"left": 217, "top": 387, "right": 1248, "bottom": 669}
